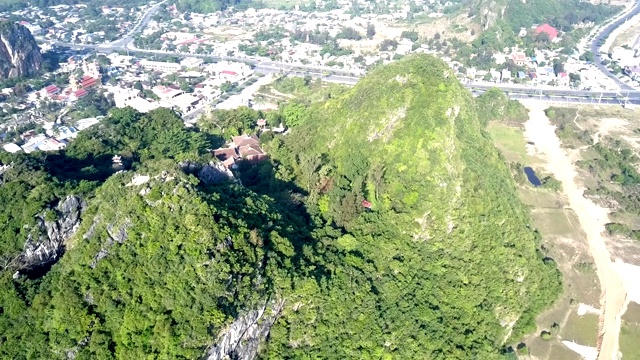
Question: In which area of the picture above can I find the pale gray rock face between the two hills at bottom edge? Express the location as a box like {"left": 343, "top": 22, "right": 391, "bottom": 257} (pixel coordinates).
{"left": 206, "top": 300, "right": 284, "bottom": 360}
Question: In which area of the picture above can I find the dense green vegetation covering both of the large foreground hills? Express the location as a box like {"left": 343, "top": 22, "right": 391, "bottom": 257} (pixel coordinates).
{"left": 0, "top": 56, "right": 559, "bottom": 359}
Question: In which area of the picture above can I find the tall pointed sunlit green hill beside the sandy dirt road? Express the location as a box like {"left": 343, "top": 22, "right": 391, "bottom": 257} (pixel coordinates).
{"left": 266, "top": 56, "right": 558, "bottom": 359}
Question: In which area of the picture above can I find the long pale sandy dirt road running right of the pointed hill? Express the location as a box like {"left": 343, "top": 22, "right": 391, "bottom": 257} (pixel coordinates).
{"left": 523, "top": 101, "right": 627, "bottom": 360}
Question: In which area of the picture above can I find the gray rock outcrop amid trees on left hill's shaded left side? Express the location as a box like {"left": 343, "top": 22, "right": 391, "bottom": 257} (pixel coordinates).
{"left": 19, "top": 196, "right": 86, "bottom": 270}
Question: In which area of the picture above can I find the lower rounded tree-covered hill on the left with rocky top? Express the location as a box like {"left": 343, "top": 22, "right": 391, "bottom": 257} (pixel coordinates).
{"left": 0, "top": 167, "right": 302, "bottom": 359}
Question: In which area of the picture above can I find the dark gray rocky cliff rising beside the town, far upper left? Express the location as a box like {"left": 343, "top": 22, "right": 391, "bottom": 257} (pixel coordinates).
{"left": 0, "top": 21, "right": 42, "bottom": 79}
